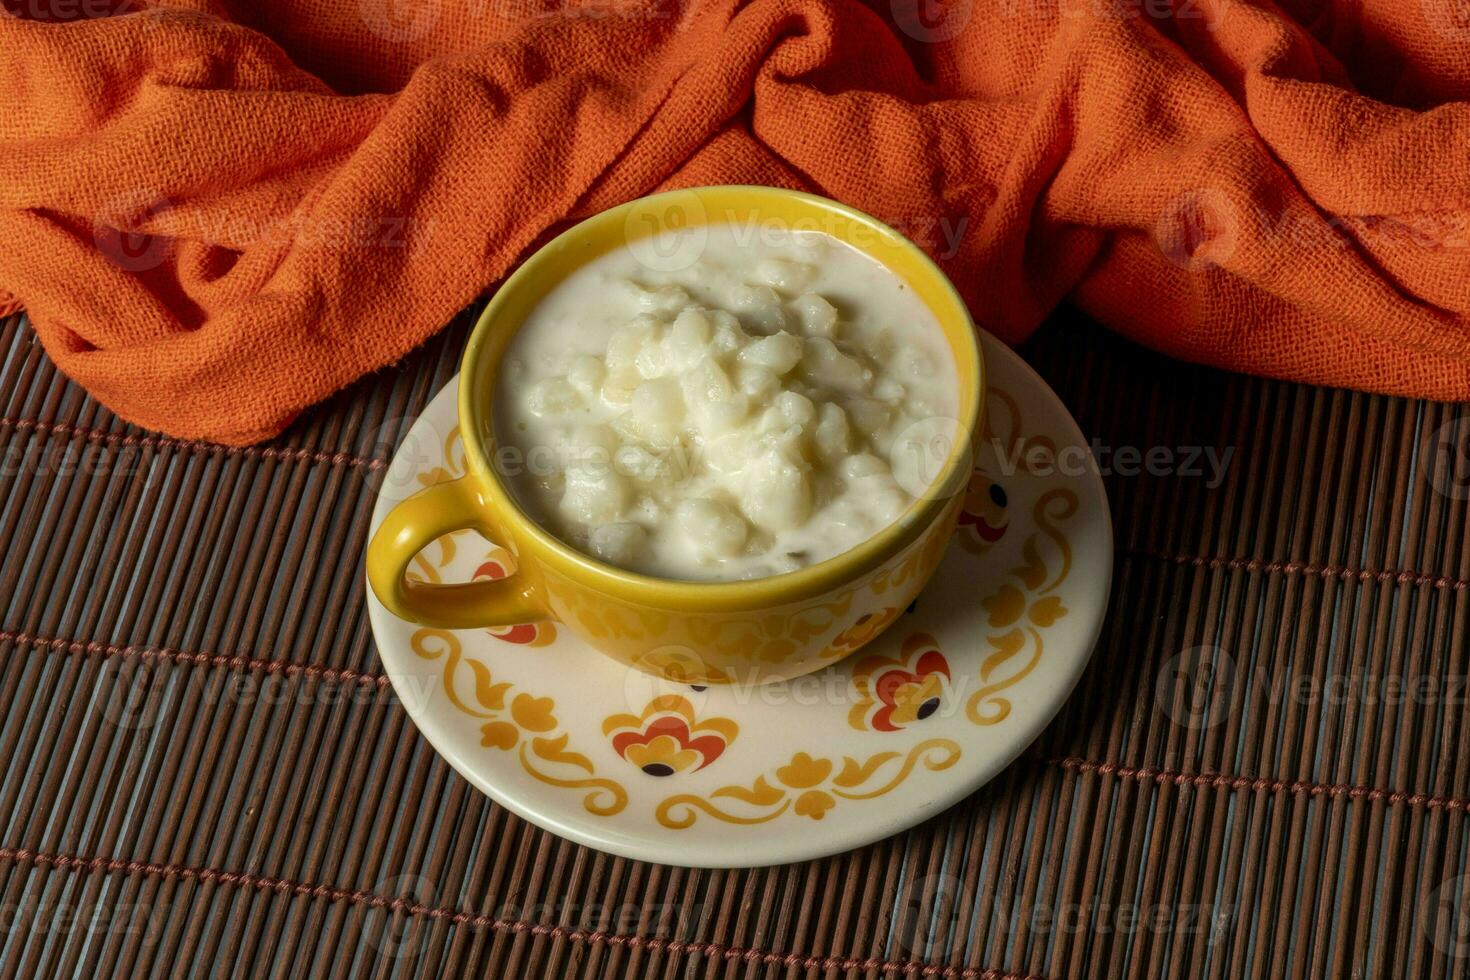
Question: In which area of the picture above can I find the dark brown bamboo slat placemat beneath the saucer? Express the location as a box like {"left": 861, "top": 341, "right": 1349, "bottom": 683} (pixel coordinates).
{"left": 0, "top": 302, "right": 1470, "bottom": 979}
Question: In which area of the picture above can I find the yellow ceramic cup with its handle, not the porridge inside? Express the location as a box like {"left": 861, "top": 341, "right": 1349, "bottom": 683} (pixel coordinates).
{"left": 368, "top": 187, "right": 985, "bottom": 683}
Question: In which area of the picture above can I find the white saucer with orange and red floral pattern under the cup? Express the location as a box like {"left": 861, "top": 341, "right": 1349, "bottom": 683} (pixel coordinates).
{"left": 368, "top": 335, "right": 1113, "bottom": 867}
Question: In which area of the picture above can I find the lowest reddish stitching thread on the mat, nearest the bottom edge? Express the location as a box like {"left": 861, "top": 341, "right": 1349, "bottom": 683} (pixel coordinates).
{"left": 0, "top": 848, "right": 1044, "bottom": 980}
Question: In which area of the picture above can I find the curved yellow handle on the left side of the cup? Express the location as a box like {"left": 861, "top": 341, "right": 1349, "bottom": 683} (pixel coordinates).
{"left": 368, "top": 476, "right": 551, "bottom": 629}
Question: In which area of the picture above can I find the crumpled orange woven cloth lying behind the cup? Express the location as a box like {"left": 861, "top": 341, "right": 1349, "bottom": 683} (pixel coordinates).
{"left": 0, "top": 0, "right": 1470, "bottom": 442}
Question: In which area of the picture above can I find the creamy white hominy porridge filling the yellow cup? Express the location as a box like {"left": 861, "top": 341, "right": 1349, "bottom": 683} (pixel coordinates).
{"left": 494, "top": 225, "right": 957, "bottom": 580}
